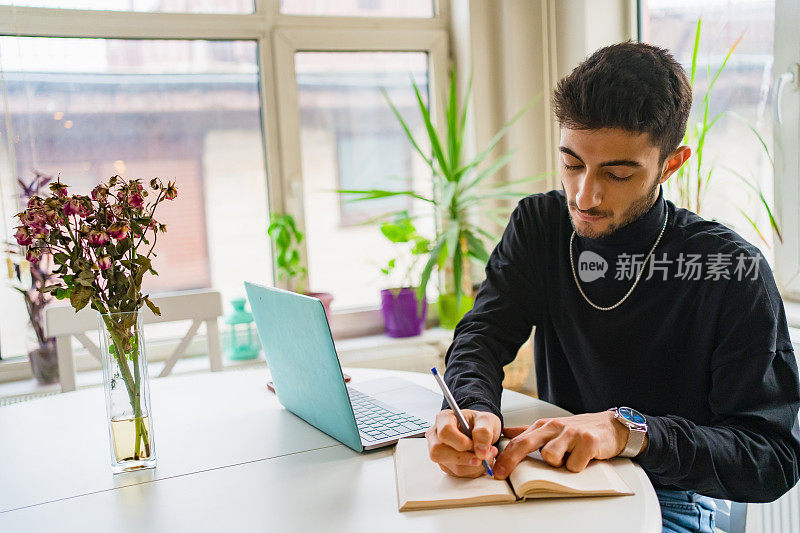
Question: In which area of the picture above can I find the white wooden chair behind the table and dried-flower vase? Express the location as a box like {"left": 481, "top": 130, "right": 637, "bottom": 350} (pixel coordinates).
{"left": 46, "top": 290, "right": 222, "bottom": 392}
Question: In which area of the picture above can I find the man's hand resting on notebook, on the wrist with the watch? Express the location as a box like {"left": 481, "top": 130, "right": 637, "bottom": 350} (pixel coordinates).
{"left": 493, "top": 411, "right": 628, "bottom": 479}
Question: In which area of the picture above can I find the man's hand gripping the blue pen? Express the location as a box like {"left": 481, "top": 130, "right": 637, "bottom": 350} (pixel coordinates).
{"left": 425, "top": 409, "right": 502, "bottom": 477}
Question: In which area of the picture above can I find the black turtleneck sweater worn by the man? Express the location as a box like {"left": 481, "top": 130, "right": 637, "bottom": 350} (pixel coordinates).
{"left": 444, "top": 185, "right": 800, "bottom": 502}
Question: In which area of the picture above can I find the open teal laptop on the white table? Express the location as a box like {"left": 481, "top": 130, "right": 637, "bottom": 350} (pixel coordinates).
{"left": 244, "top": 282, "right": 442, "bottom": 452}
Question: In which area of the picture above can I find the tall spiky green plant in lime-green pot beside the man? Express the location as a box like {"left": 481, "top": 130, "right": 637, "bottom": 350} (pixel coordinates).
{"left": 338, "top": 70, "right": 544, "bottom": 328}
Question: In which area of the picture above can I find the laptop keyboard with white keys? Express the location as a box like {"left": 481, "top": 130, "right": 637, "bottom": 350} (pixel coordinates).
{"left": 348, "top": 387, "right": 430, "bottom": 442}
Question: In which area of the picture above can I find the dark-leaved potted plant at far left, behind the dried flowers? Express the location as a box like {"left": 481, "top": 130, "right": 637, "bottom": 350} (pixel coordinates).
{"left": 6, "top": 170, "right": 58, "bottom": 385}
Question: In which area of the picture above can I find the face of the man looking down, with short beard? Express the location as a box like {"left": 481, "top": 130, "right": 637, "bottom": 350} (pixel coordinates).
{"left": 559, "top": 128, "right": 691, "bottom": 239}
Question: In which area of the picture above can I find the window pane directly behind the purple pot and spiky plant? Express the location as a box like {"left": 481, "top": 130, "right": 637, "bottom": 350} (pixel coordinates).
{"left": 295, "top": 52, "right": 433, "bottom": 309}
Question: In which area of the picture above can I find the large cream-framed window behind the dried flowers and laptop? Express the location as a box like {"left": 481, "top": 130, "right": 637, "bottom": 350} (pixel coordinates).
{"left": 0, "top": 0, "right": 447, "bottom": 359}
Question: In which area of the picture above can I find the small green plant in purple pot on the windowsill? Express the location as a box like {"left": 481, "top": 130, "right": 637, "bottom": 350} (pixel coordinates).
{"left": 380, "top": 211, "right": 431, "bottom": 337}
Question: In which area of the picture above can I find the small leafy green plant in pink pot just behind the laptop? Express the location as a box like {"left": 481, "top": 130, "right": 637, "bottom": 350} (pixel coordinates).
{"left": 267, "top": 214, "right": 333, "bottom": 321}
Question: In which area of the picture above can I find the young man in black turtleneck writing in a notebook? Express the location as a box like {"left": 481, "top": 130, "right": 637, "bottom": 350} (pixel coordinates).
{"left": 427, "top": 42, "right": 800, "bottom": 531}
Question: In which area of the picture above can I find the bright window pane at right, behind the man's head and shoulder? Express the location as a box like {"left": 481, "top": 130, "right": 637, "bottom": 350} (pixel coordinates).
{"left": 640, "top": 0, "right": 780, "bottom": 264}
